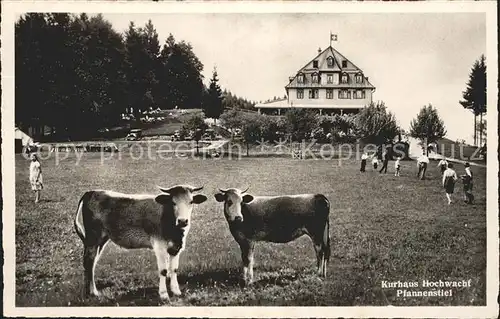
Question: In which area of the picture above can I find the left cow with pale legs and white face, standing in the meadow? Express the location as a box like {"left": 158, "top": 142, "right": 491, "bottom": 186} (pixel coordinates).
{"left": 75, "top": 185, "right": 207, "bottom": 300}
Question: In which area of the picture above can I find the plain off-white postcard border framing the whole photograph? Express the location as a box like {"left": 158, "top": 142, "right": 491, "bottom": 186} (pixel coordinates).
{"left": 1, "top": 1, "right": 499, "bottom": 318}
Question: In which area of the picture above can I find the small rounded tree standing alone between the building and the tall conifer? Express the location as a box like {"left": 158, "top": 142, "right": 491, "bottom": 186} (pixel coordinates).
{"left": 410, "top": 104, "right": 446, "bottom": 154}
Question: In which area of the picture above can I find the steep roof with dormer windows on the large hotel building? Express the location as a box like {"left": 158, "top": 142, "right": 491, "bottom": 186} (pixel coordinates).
{"left": 285, "top": 46, "right": 375, "bottom": 89}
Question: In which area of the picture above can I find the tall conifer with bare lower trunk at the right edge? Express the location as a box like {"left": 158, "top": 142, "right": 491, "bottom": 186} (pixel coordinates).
{"left": 460, "top": 55, "right": 486, "bottom": 145}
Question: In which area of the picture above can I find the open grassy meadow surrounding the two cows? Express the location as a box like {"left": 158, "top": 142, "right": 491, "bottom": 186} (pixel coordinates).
{"left": 15, "top": 153, "right": 486, "bottom": 307}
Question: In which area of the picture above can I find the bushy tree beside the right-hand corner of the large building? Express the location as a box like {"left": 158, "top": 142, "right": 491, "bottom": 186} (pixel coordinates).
{"left": 355, "top": 101, "right": 399, "bottom": 145}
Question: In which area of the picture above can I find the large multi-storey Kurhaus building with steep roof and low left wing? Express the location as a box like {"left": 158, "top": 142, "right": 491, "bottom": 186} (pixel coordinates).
{"left": 255, "top": 45, "right": 375, "bottom": 115}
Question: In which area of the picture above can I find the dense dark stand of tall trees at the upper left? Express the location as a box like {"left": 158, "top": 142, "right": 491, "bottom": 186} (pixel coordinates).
{"left": 15, "top": 13, "right": 206, "bottom": 138}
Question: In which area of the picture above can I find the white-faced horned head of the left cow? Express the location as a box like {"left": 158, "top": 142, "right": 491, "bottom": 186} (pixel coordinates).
{"left": 155, "top": 185, "right": 207, "bottom": 228}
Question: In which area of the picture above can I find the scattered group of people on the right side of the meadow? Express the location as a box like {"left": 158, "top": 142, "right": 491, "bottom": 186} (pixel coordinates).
{"left": 360, "top": 150, "right": 474, "bottom": 205}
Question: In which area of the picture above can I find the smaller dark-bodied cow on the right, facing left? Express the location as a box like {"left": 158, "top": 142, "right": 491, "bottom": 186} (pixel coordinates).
{"left": 215, "top": 188, "right": 331, "bottom": 284}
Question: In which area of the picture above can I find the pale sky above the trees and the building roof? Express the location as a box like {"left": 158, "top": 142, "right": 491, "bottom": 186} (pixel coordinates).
{"left": 104, "top": 13, "right": 486, "bottom": 142}
